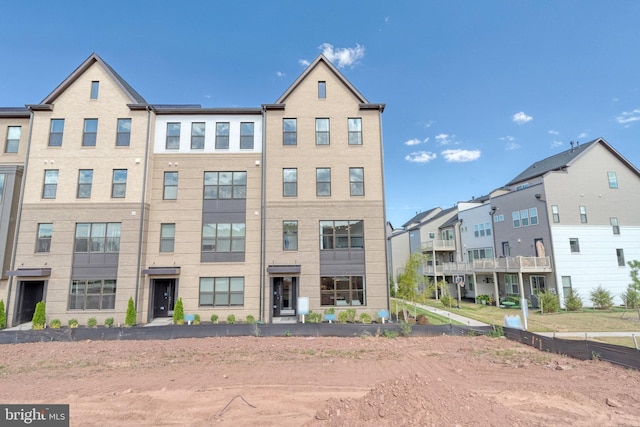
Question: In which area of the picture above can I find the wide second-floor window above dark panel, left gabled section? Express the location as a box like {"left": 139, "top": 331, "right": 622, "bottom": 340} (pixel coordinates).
{"left": 74, "top": 222, "right": 120, "bottom": 253}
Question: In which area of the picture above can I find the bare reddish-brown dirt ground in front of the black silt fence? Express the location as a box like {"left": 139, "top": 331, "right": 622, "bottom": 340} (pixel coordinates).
{"left": 0, "top": 336, "right": 640, "bottom": 427}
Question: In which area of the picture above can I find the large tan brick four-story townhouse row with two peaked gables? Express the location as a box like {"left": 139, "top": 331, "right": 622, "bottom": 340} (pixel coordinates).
{"left": 0, "top": 54, "right": 389, "bottom": 325}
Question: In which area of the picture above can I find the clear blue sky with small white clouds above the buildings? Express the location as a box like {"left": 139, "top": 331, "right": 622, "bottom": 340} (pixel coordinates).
{"left": 0, "top": 0, "right": 640, "bottom": 227}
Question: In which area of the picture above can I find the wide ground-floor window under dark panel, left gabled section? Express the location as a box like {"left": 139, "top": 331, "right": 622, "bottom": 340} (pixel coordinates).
{"left": 69, "top": 279, "right": 116, "bottom": 310}
